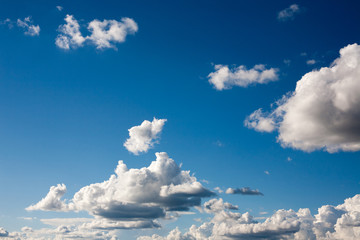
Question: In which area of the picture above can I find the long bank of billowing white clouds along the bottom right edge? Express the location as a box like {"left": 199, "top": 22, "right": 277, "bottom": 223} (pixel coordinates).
{"left": 138, "top": 195, "right": 360, "bottom": 240}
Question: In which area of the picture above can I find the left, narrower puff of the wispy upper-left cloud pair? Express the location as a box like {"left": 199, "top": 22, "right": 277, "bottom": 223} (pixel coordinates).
{"left": 55, "top": 15, "right": 85, "bottom": 49}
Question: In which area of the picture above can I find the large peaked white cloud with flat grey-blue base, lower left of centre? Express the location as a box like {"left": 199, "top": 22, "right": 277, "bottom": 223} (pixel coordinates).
{"left": 26, "top": 152, "right": 214, "bottom": 228}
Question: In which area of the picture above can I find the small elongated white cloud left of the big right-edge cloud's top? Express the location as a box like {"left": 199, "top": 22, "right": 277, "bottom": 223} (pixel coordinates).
{"left": 208, "top": 64, "right": 278, "bottom": 90}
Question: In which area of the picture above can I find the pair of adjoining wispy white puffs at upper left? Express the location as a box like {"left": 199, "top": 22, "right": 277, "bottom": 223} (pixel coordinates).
{"left": 55, "top": 15, "right": 138, "bottom": 49}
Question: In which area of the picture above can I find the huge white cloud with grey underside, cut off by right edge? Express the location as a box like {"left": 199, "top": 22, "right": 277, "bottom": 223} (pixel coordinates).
{"left": 245, "top": 44, "right": 360, "bottom": 153}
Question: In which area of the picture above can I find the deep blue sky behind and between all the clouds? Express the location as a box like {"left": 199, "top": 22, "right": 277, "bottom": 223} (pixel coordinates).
{"left": 0, "top": 1, "right": 360, "bottom": 239}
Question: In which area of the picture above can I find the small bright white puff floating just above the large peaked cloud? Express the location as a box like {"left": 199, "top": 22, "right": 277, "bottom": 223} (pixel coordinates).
{"left": 124, "top": 118, "right": 166, "bottom": 155}
